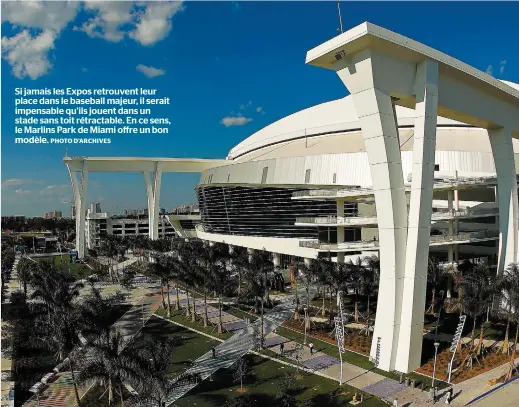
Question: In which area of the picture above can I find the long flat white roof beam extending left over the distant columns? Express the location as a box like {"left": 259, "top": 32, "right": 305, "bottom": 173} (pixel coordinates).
{"left": 63, "top": 157, "right": 229, "bottom": 173}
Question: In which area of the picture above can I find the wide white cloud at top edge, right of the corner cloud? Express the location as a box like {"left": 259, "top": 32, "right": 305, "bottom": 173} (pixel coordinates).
{"left": 74, "top": 0, "right": 183, "bottom": 45}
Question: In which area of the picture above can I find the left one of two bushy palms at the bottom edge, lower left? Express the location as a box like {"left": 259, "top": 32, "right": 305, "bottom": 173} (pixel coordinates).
{"left": 77, "top": 331, "right": 146, "bottom": 405}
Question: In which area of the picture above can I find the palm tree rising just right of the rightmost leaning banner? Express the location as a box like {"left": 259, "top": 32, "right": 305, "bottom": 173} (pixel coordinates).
{"left": 459, "top": 263, "right": 499, "bottom": 355}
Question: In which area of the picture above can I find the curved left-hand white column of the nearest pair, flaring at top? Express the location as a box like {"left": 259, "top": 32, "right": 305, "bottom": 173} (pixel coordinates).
{"left": 337, "top": 51, "right": 407, "bottom": 371}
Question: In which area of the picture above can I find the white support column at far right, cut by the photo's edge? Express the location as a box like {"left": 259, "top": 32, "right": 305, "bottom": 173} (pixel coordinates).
{"left": 488, "top": 127, "right": 519, "bottom": 273}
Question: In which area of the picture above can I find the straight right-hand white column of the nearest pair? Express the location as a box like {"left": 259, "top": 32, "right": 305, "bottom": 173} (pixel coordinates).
{"left": 395, "top": 60, "right": 438, "bottom": 372}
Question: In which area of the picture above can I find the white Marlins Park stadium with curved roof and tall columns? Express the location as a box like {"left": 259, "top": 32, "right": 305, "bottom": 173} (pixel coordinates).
{"left": 64, "top": 23, "right": 519, "bottom": 372}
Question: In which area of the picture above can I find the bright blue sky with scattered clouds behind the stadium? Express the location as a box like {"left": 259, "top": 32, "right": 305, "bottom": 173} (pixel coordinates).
{"left": 1, "top": 1, "right": 519, "bottom": 216}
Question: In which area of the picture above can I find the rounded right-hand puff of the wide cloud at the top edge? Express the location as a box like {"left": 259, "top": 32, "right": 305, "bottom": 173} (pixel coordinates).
{"left": 129, "top": 1, "right": 184, "bottom": 45}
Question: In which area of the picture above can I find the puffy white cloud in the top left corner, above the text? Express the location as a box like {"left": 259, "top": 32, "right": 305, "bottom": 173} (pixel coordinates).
{"left": 2, "top": 1, "right": 79, "bottom": 79}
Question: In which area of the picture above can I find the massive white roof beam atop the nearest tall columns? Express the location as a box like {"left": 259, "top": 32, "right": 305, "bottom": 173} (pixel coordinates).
{"left": 306, "top": 22, "right": 519, "bottom": 138}
